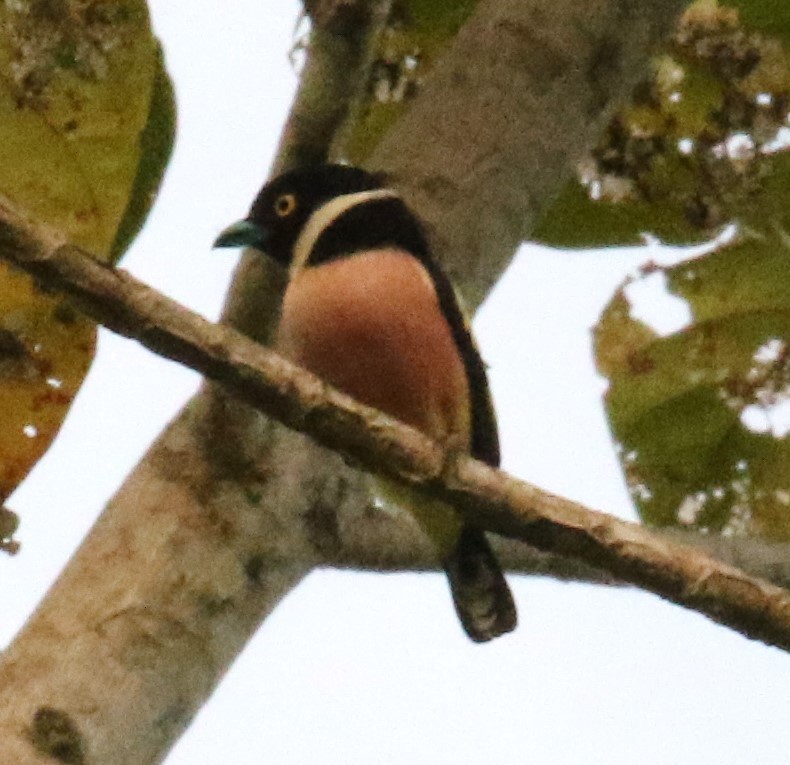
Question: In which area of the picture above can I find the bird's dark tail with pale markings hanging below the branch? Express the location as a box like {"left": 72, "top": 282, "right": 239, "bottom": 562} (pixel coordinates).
{"left": 445, "top": 526, "right": 516, "bottom": 643}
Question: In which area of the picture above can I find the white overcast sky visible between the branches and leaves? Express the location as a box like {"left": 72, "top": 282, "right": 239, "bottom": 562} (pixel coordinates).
{"left": 0, "top": 0, "right": 790, "bottom": 765}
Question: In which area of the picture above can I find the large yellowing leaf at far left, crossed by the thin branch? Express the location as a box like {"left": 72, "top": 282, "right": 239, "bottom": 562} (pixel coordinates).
{"left": 0, "top": 0, "right": 174, "bottom": 512}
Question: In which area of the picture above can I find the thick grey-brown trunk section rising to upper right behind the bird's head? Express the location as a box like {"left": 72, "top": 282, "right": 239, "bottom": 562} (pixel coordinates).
{"left": 371, "top": 0, "right": 685, "bottom": 306}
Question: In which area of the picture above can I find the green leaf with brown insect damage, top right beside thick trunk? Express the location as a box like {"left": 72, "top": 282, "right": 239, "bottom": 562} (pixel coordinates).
{"left": 534, "top": 0, "right": 790, "bottom": 247}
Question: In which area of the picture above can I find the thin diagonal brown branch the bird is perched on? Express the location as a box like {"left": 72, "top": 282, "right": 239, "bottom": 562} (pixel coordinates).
{"left": 0, "top": 201, "right": 790, "bottom": 650}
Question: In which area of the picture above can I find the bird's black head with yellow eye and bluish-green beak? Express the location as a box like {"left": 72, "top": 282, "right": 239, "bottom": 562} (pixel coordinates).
{"left": 214, "top": 165, "right": 384, "bottom": 266}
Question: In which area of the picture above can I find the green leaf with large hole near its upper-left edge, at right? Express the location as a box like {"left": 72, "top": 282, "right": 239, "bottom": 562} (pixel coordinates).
{"left": 596, "top": 236, "right": 790, "bottom": 540}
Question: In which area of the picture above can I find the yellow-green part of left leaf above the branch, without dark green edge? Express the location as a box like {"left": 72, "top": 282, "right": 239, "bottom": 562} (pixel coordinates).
{"left": 0, "top": 0, "right": 158, "bottom": 257}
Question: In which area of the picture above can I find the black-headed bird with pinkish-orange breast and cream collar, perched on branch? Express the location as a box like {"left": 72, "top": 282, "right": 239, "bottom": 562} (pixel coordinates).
{"left": 214, "top": 164, "right": 517, "bottom": 643}
